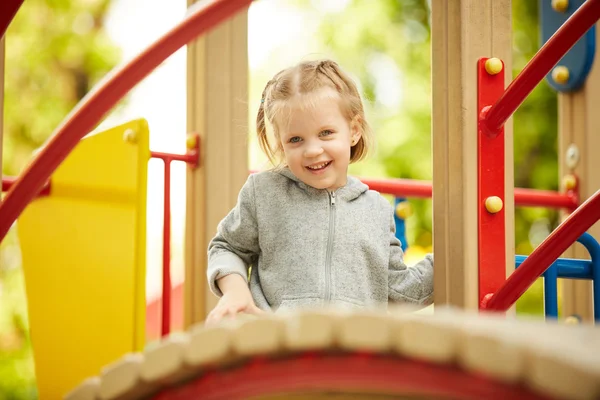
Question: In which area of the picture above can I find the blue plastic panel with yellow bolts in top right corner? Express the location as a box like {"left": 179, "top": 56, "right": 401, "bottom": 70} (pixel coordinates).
{"left": 539, "top": 0, "right": 596, "bottom": 92}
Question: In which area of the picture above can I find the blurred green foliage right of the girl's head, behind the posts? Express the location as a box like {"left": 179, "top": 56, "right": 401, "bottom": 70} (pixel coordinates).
{"left": 292, "top": 0, "right": 558, "bottom": 312}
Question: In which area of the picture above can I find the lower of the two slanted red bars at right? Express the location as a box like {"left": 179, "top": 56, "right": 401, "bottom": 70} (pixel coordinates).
{"left": 484, "top": 190, "right": 600, "bottom": 311}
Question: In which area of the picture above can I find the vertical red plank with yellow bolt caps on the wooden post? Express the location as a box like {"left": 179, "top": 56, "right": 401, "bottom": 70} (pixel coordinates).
{"left": 477, "top": 58, "right": 506, "bottom": 304}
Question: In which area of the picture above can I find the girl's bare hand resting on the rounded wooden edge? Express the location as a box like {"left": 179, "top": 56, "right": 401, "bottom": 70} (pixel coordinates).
{"left": 205, "top": 274, "right": 264, "bottom": 325}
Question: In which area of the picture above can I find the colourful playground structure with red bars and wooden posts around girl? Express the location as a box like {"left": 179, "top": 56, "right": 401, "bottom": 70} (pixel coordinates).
{"left": 0, "top": 0, "right": 600, "bottom": 399}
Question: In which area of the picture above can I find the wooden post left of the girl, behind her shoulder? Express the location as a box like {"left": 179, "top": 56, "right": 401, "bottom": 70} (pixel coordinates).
{"left": 184, "top": 4, "right": 248, "bottom": 327}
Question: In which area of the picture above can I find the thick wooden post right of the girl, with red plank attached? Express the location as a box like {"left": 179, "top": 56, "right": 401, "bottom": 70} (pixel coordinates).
{"left": 432, "top": 0, "right": 514, "bottom": 309}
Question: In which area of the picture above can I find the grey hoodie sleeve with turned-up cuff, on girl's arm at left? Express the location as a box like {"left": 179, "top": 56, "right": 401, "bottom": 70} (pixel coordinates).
{"left": 207, "top": 175, "right": 259, "bottom": 297}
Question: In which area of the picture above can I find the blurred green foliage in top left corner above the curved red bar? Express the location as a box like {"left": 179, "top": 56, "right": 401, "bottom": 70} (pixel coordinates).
{"left": 2, "top": 0, "right": 119, "bottom": 175}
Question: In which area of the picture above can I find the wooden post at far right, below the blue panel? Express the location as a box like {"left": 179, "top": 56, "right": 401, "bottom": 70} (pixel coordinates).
{"left": 558, "top": 24, "right": 600, "bottom": 321}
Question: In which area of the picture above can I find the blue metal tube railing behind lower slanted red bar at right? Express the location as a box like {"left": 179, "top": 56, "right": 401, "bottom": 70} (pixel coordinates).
{"left": 515, "top": 232, "right": 600, "bottom": 322}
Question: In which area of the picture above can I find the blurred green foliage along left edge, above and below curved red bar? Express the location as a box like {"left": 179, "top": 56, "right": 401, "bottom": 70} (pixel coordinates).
{"left": 0, "top": 0, "right": 120, "bottom": 400}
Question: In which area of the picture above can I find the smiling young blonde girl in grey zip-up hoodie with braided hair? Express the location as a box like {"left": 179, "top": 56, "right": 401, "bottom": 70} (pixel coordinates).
{"left": 206, "top": 60, "right": 433, "bottom": 323}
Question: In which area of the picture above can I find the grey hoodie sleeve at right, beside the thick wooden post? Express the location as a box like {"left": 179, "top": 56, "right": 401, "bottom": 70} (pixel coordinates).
{"left": 388, "top": 214, "right": 433, "bottom": 305}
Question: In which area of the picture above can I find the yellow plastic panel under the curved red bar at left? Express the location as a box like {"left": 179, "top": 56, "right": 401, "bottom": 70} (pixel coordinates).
{"left": 17, "top": 120, "right": 150, "bottom": 400}
